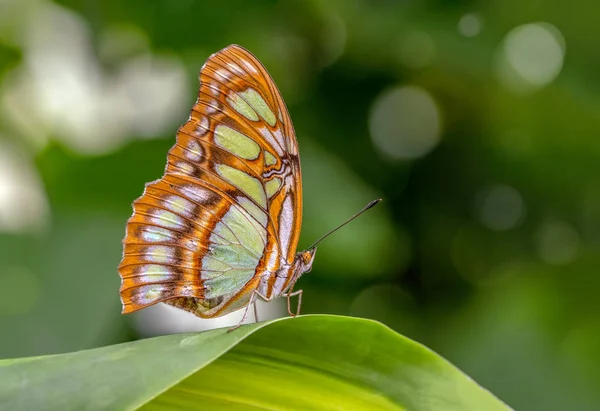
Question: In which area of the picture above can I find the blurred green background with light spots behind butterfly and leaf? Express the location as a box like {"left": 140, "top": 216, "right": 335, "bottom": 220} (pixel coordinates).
{"left": 0, "top": 0, "right": 600, "bottom": 411}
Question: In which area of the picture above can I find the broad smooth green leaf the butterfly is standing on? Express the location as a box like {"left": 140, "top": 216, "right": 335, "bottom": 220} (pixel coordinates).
{"left": 0, "top": 315, "right": 510, "bottom": 411}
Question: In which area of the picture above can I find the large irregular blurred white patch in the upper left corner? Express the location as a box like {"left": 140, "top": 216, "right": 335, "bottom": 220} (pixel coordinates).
{"left": 1, "top": 4, "right": 188, "bottom": 154}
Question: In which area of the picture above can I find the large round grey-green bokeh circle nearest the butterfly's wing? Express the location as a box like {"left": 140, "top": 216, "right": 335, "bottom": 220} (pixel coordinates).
{"left": 369, "top": 86, "right": 441, "bottom": 159}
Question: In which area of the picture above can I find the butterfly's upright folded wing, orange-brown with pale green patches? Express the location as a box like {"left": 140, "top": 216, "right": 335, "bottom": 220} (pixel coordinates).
{"left": 119, "top": 45, "right": 302, "bottom": 317}
